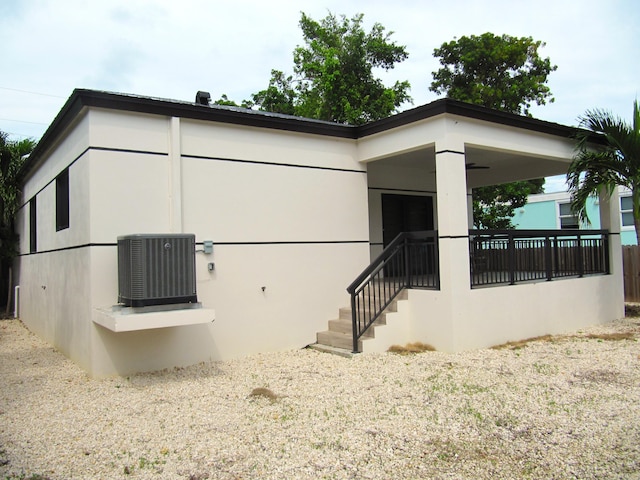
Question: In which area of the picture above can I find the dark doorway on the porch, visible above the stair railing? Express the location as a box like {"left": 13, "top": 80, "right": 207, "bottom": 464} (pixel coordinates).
{"left": 382, "top": 194, "right": 433, "bottom": 247}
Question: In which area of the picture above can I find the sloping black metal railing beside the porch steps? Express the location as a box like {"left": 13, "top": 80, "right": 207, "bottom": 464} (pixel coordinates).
{"left": 347, "top": 231, "right": 440, "bottom": 353}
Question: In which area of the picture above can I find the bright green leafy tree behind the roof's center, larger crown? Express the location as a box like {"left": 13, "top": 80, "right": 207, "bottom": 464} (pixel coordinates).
{"left": 245, "top": 13, "right": 411, "bottom": 125}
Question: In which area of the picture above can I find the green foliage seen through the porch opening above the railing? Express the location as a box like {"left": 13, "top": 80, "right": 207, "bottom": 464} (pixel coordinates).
{"left": 473, "top": 178, "right": 544, "bottom": 230}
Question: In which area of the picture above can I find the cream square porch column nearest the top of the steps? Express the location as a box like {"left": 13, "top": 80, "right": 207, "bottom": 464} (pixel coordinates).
{"left": 436, "top": 142, "right": 471, "bottom": 297}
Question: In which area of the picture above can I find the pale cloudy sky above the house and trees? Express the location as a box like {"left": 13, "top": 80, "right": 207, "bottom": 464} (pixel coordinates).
{"left": 0, "top": 0, "right": 640, "bottom": 191}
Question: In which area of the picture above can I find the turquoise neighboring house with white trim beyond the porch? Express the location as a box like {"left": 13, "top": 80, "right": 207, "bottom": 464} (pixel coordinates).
{"left": 512, "top": 187, "right": 638, "bottom": 245}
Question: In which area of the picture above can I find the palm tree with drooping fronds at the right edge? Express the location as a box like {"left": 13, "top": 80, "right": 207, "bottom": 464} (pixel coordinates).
{"left": 567, "top": 100, "right": 640, "bottom": 245}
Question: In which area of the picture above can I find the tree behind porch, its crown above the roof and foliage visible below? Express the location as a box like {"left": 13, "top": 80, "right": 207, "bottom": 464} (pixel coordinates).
{"left": 430, "top": 33, "right": 557, "bottom": 229}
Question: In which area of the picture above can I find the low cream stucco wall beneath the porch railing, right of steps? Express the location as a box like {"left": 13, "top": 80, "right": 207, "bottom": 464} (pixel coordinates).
{"left": 409, "top": 275, "right": 624, "bottom": 352}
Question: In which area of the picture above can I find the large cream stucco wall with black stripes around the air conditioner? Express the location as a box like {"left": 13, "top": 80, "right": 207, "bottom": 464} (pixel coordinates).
{"left": 18, "top": 109, "right": 369, "bottom": 376}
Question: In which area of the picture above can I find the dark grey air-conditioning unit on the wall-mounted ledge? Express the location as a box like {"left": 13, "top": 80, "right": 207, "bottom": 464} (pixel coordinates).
{"left": 118, "top": 234, "right": 198, "bottom": 307}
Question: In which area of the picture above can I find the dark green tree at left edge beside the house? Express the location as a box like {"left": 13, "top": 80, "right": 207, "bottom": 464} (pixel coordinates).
{"left": 0, "top": 132, "right": 36, "bottom": 311}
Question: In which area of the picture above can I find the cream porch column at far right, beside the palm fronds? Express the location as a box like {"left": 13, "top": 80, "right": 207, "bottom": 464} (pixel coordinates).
{"left": 599, "top": 188, "right": 624, "bottom": 317}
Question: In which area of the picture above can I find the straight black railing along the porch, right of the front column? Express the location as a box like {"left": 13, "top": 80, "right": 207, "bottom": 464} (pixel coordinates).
{"left": 469, "top": 230, "right": 609, "bottom": 287}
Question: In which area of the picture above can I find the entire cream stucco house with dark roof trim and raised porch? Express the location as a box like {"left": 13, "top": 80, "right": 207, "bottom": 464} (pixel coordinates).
{"left": 16, "top": 90, "right": 624, "bottom": 376}
